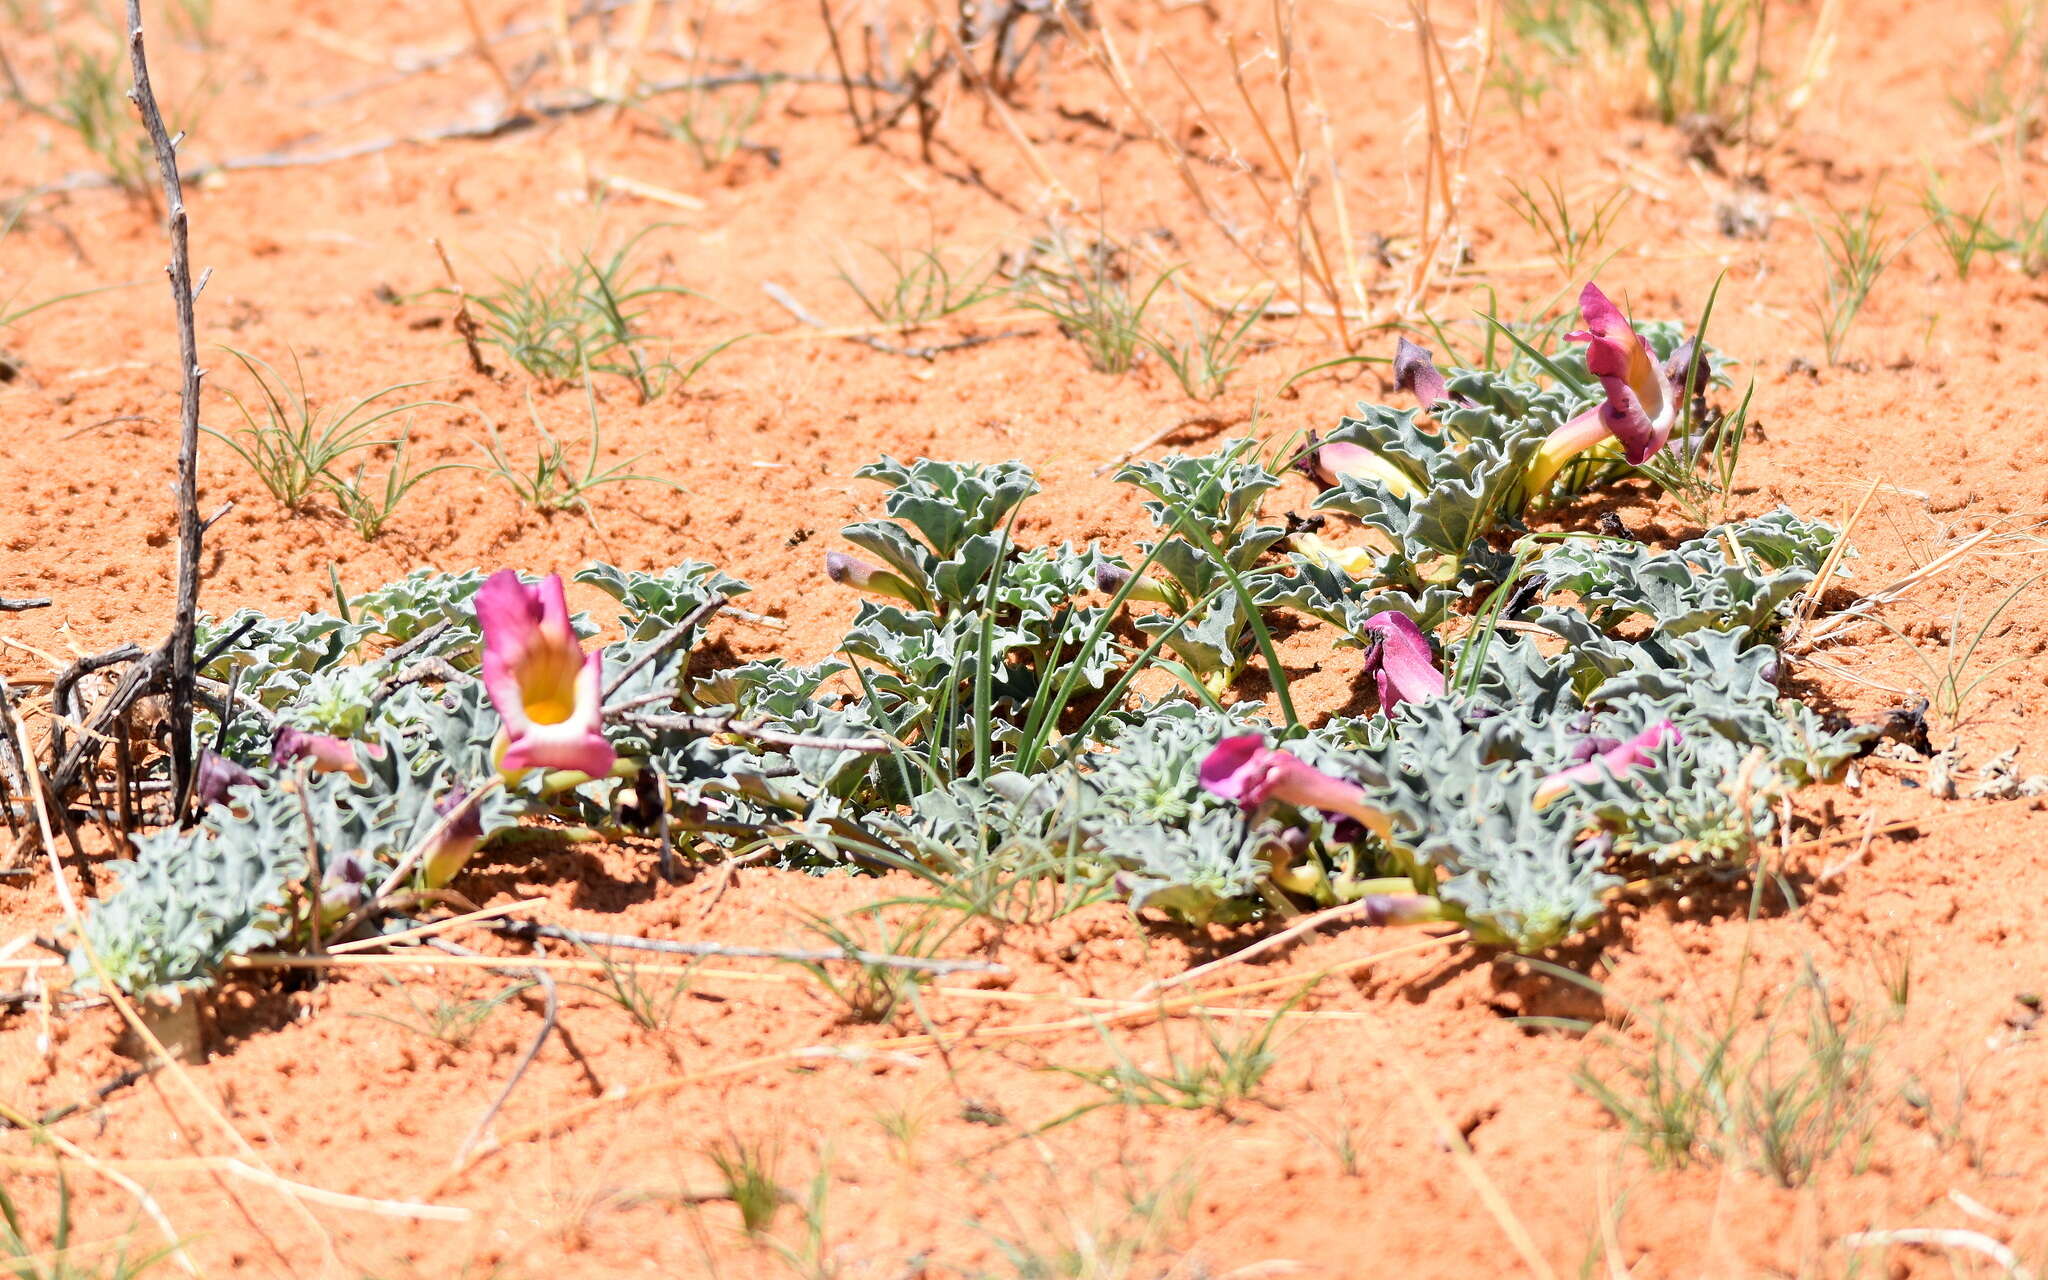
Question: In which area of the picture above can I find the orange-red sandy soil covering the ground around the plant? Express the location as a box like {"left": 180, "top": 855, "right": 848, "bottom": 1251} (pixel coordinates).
{"left": 0, "top": 0, "right": 2048, "bottom": 1278}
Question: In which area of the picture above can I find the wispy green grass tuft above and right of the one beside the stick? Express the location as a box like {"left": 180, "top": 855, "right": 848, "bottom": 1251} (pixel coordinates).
{"left": 462, "top": 227, "right": 745, "bottom": 403}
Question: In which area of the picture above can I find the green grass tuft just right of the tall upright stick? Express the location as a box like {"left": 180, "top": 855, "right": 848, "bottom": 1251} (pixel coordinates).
{"left": 201, "top": 346, "right": 453, "bottom": 510}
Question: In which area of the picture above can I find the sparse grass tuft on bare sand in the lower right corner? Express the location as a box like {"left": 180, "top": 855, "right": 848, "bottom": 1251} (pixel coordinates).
{"left": 1575, "top": 969, "right": 1876, "bottom": 1188}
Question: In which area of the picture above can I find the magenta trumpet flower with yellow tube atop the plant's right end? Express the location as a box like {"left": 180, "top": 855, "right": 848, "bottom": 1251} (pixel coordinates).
{"left": 1526, "top": 285, "right": 1692, "bottom": 496}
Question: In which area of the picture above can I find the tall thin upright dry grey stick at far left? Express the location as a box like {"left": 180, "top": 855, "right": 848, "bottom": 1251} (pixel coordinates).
{"left": 127, "top": 0, "right": 205, "bottom": 817}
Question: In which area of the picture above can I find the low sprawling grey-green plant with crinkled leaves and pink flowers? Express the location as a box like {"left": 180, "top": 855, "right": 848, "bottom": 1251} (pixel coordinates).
{"left": 86, "top": 276, "right": 1868, "bottom": 999}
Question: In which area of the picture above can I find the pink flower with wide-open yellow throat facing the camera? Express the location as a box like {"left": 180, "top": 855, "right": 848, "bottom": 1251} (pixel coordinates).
{"left": 477, "top": 569, "right": 616, "bottom": 778}
